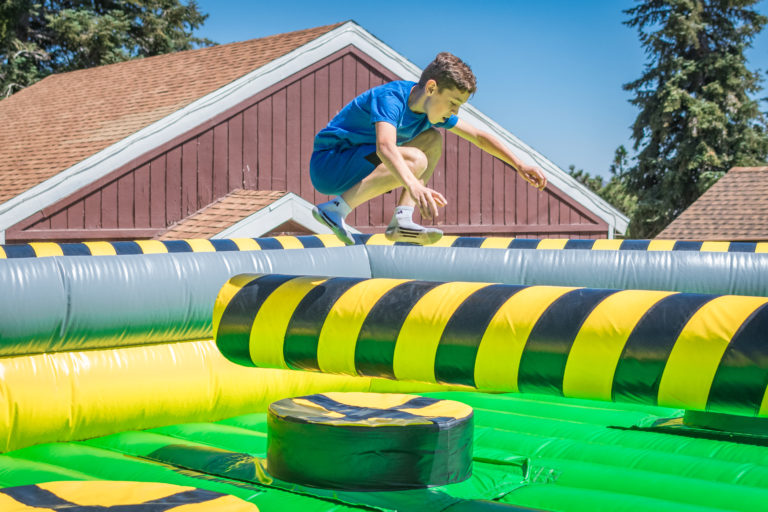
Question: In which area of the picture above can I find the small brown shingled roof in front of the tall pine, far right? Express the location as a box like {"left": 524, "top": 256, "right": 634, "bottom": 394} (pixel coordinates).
{"left": 656, "top": 167, "right": 768, "bottom": 241}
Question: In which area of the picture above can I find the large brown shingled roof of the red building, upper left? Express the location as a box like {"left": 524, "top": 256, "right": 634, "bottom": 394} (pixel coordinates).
{"left": 0, "top": 23, "right": 341, "bottom": 203}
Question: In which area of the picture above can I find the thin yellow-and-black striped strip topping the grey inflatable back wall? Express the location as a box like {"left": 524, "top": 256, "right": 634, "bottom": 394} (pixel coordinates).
{"left": 0, "top": 234, "right": 768, "bottom": 259}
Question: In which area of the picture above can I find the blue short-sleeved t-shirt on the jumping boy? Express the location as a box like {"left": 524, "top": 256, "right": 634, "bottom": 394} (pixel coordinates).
{"left": 314, "top": 80, "right": 459, "bottom": 151}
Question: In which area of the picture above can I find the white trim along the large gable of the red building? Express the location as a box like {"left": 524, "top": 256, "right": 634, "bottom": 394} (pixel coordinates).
{"left": 0, "top": 21, "right": 629, "bottom": 240}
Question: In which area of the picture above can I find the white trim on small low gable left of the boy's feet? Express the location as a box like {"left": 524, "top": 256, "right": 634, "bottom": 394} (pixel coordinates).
{"left": 211, "top": 192, "right": 360, "bottom": 238}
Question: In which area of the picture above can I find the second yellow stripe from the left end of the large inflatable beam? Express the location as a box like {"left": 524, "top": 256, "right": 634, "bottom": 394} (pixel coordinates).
{"left": 248, "top": 277, "right": 327, "bottom": 368}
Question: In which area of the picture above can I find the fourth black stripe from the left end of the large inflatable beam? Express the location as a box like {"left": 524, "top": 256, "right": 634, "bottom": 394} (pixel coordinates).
{"left": 435, "top": 284, "right": 525, "bottom": 386}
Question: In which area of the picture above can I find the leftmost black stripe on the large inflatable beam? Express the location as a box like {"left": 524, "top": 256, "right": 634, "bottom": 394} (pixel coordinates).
{"left": 219, "top": 274, "right": 295, "bottom": 366}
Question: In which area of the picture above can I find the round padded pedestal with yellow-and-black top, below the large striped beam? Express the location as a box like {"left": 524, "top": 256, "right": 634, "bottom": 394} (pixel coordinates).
{"left": 267, "top": 393, "right": 472, "bottom": 491}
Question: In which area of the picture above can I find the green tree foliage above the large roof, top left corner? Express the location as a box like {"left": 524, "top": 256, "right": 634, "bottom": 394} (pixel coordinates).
{"left": 0, "top": 0, "right": 212, "bottom": 98}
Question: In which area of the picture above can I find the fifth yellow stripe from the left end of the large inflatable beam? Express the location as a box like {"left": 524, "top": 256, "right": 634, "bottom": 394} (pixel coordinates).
{"left": 475, "top": 286, "right": 576, "bottom": 392}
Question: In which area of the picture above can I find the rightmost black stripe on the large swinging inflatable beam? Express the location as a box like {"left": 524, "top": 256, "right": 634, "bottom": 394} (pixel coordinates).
{"left": 707, "top": 305, "right": 768, "bottom": 416}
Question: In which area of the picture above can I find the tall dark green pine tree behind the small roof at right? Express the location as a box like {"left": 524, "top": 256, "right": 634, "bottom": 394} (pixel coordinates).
{"left": 624, "top": 0, "right": 768, "bottom": 238}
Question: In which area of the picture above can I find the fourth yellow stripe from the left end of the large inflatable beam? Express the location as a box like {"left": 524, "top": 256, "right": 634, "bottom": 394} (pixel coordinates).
{"left": 392, "top": 282, "right": 489, "bottom": 382}
